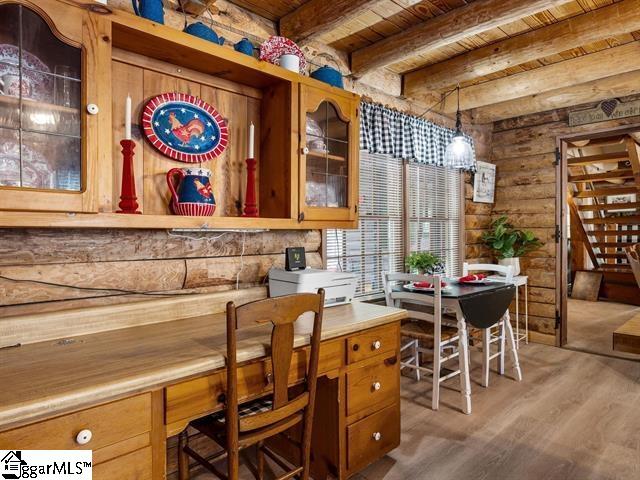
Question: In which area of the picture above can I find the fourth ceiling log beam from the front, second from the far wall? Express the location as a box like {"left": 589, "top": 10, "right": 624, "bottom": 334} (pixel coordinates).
{"left": 438, "top": 42, "right": 640, "bottom": 113}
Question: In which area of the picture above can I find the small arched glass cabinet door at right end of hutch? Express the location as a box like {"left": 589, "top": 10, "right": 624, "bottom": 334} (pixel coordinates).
{"left": 300, "top": 85, "right": 359, "bottom": 221}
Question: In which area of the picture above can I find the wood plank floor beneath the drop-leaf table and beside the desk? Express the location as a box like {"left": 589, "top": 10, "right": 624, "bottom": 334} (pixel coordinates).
{"left": 198, "top": 344, "right": 640, "bottom": 480}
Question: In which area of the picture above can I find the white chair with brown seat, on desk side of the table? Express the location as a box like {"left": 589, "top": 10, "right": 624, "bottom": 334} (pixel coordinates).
{"left": 382, "top": 273, "right": 469, "bottom": 412}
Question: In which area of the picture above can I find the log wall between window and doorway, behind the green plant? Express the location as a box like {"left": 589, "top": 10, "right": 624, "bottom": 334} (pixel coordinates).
{"left": 482, "top": 96, "right": 640, "bottom": 344}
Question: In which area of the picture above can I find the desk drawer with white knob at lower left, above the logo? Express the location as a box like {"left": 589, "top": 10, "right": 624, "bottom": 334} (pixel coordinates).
{"left": 0, "top": 393, "right": 151, "bottom": 463}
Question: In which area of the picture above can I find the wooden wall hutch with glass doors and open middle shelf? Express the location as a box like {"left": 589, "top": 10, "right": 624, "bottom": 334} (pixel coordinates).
{"left": 0, "top": 0, "right": 359, "bottom": 229}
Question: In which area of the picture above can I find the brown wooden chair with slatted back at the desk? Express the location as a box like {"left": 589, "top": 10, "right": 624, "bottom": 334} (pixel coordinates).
{"left": 178, "top": 289, "right": 324, "bottom": 480}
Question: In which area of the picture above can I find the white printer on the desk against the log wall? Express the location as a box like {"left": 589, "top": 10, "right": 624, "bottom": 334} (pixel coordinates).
{"left": 269, "top": 268, "right": 357, "bottom": 307}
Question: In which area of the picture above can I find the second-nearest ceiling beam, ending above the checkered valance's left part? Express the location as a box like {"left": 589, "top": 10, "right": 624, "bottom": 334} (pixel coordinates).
{"left": 350, "top": 0, "right": 568, "bottom": 76}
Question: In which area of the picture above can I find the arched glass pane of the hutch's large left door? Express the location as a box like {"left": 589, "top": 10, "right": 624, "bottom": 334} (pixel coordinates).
{"left": 0, "top": 4, "right": 83, "bottom": 192}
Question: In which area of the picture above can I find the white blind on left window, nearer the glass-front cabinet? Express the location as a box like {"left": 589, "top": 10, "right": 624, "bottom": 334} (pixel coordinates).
{"left": 326, "top": 152, "right": 404, "bottom": 296}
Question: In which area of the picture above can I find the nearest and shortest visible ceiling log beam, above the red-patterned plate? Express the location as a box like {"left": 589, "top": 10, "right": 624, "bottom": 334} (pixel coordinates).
{"left": 280, "top": 0, "right": 384, "bottom": 42}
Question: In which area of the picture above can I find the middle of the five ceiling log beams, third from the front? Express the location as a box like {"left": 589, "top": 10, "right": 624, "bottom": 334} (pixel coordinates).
{"left": 405, "top": 0, "right": 640, "bottom": 92}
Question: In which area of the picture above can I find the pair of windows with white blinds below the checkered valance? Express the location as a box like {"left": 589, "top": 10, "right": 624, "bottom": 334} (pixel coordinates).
{"left": 325, "top": 151, "right": 462, "bottom": 297}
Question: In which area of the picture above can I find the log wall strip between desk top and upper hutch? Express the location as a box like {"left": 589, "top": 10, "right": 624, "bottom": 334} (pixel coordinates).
{"left": 0, "top": 229, "right": 322, "bottom": 317}
